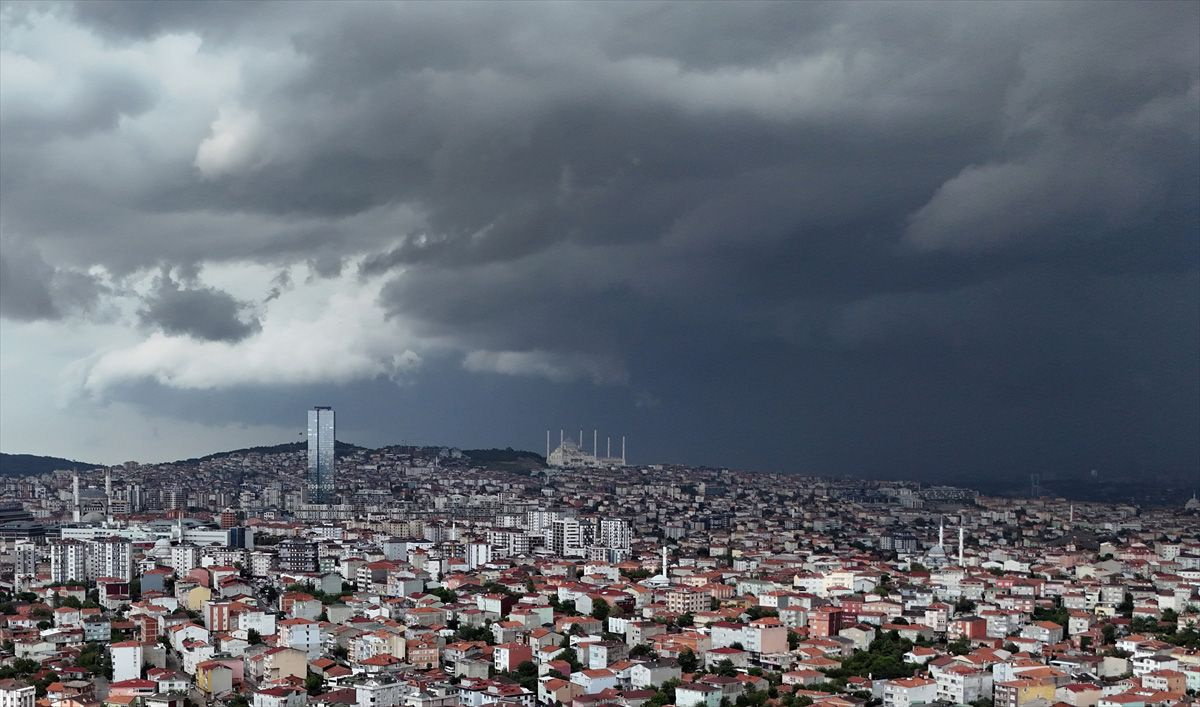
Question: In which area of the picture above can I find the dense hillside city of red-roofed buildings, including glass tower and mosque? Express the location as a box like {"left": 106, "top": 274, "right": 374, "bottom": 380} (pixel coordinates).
{"left": 0, "top": 407, "right": 1200, "bottom": 707}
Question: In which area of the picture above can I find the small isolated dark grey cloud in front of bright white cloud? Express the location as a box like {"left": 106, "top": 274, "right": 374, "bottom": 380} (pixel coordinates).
{"left": 138, "top": 272, "right": 262, "bottom": 342}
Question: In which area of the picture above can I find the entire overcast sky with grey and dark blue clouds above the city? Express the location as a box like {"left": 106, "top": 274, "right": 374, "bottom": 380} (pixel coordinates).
{"left": 0, "top": 1, "right": 1200, "bottom": 479}
